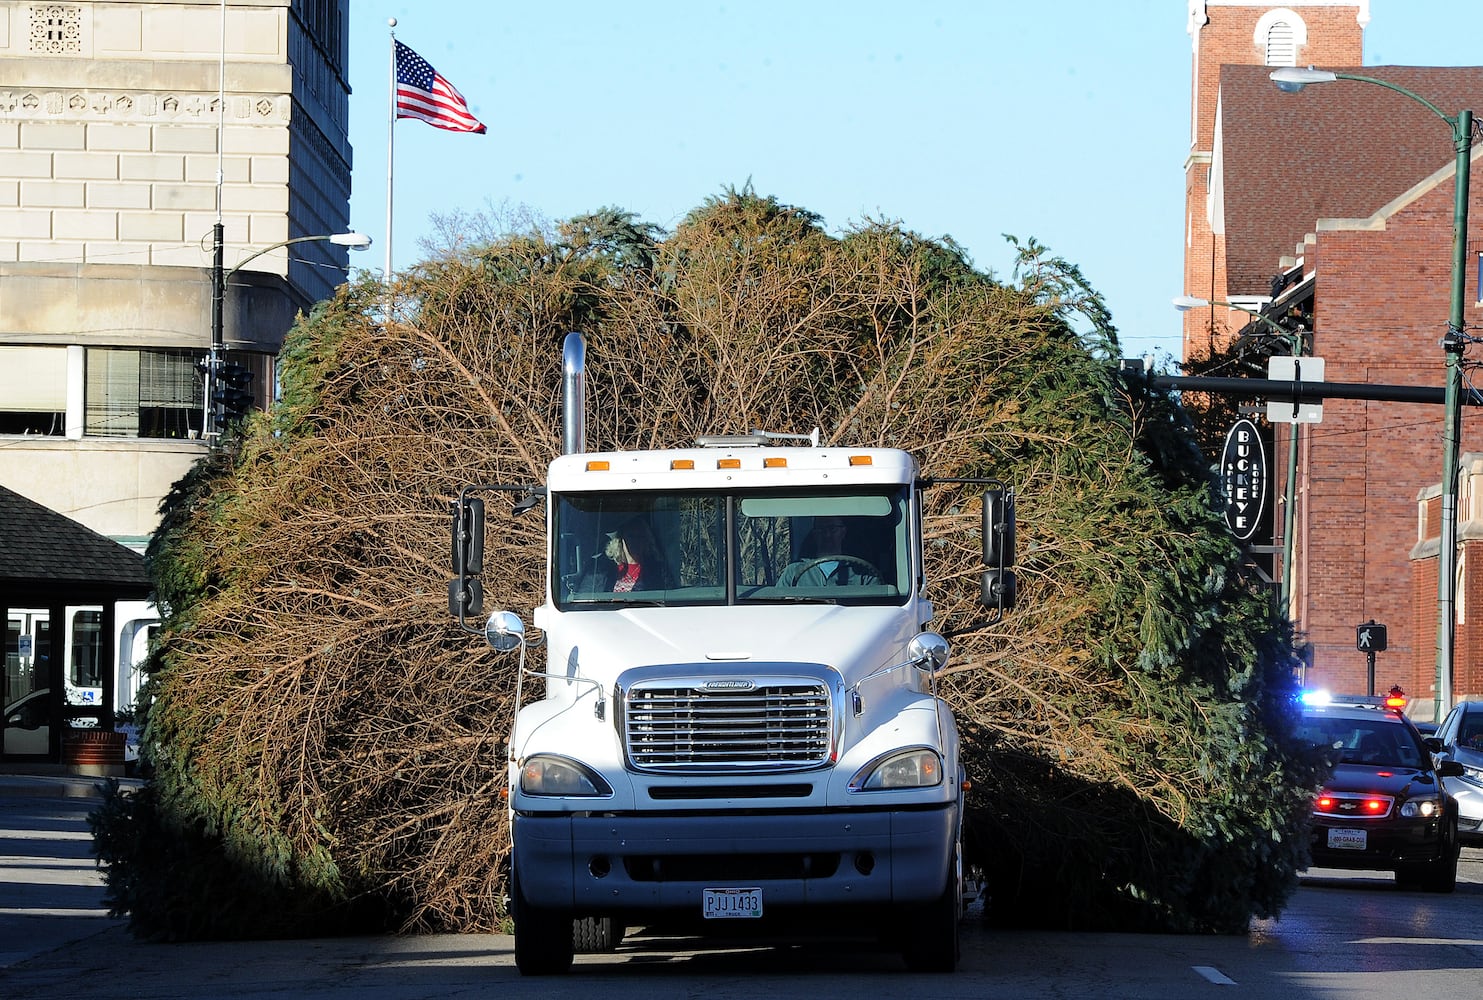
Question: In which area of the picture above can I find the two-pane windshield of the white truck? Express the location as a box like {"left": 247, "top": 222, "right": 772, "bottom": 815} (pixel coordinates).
{"left": 550, "top": 485, "right": 912, "bottom": 608}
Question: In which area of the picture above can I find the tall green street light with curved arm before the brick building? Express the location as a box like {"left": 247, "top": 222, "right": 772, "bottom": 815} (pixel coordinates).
{"left": 1271, "top": 67, "right": 1473, "bottom": 723}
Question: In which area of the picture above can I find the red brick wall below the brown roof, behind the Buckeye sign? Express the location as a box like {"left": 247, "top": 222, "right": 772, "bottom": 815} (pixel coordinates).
{"left": 1299, "top": 169, "right": 1483, "bottom": 696}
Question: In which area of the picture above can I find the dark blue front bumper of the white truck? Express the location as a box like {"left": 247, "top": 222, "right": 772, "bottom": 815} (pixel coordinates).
{"left": 513, "top": 803, "right": 958, "bottom": 914}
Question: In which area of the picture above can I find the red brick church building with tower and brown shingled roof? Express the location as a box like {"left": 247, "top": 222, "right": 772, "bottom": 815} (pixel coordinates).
{"left": 1183, "top": 0, "right": 1483, "bottom": 718}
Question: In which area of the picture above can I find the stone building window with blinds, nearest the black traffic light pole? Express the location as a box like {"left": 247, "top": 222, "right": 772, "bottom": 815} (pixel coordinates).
{"left": 83, "top": 347, "right": 202, "bottom": 438}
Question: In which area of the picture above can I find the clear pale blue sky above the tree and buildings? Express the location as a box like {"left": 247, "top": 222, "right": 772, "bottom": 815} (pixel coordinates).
{"left": 350, "top": 0, "right": 1483, "bottom": 358}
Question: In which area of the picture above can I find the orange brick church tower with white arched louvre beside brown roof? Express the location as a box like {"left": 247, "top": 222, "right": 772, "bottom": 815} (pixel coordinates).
{"left": 1183, "top": 0, "right": 1370, "bottom": 359}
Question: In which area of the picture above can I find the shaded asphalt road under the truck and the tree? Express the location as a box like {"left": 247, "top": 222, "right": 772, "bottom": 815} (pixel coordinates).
{"left": 0, "top": 779, "right": 1483, "bottom": 1000}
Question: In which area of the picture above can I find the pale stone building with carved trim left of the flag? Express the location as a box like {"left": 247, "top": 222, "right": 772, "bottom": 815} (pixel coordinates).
{"left": 0, "top": 0, "right": 350, "bottom": 546}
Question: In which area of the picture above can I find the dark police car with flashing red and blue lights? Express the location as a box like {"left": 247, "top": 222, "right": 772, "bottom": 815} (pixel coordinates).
{"left": 1301, "top": 688, "right": 1462, "bottom": 892}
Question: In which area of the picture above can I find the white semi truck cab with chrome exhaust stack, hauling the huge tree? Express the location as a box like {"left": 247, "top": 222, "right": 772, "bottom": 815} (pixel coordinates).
{"left": 449, "top": 334, "right": 1014, "bottom": 975}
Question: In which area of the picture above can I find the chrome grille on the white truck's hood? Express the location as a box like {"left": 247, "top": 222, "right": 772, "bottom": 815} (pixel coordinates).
{"left": 623, "top": 681, "right": 832, "bottom": 772}
